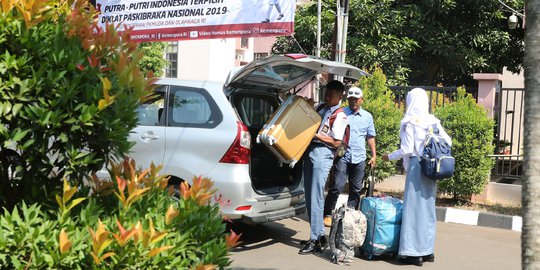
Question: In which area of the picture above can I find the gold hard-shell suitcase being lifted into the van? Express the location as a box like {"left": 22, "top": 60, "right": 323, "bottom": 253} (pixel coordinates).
{"left": 257, "top": 95, "right": 321, "bottom": 168}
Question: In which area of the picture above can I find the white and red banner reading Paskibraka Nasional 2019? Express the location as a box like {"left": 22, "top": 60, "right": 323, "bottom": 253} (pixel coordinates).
{"left": 96, "top": 0, "right": 296, "bottom": 42}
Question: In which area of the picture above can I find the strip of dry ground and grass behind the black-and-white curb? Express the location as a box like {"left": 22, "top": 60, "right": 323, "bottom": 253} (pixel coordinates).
{"left": 374, "top": 191, "right": 522, "bottom": 216}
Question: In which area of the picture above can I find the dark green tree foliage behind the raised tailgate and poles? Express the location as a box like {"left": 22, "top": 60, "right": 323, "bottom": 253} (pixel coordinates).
{"left": 273, "top": 0, "right": 524, "bottom": 85}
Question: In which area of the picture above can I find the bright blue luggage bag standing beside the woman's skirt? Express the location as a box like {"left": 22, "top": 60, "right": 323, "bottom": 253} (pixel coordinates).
{"left": 360, "top": 196, "right": 403, "bottom": 260}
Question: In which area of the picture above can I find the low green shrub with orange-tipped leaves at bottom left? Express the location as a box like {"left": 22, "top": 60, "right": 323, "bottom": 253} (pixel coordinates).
{"left": 0, "top": 160, "right": 239, "bottom": 269}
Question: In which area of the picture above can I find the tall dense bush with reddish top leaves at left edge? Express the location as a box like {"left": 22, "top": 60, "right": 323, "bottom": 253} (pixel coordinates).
{"left": 0, "top": 0, "right": 152, "bottom": 207}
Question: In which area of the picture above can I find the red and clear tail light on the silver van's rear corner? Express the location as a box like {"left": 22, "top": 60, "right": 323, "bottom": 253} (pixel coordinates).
{"left": 219, "top": 121, "right": 251, "bottom": 164}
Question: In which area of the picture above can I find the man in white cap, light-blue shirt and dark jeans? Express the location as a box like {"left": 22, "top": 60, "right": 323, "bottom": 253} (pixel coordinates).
{"left": 324, "top": 87, "right": 377, "bottom": 227}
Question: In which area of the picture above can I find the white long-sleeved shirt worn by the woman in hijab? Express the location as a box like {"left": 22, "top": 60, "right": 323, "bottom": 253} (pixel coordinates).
{"left": 388, "top": 120, "right": 452, "bottom": 170}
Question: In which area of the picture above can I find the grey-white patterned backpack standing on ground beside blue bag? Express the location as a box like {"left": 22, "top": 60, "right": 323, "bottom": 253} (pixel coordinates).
{"left": 329, "top": 205, "right": 367, "bottom": 264}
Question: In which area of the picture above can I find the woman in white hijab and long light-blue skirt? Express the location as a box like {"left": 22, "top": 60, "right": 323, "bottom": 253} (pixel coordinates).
{"left": 383, "top": 88, "right": 452, "bottom": 266}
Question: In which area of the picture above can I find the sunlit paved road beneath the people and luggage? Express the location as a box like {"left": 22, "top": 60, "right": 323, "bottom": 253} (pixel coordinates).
{"left": 231, "top": 216, "right": 521, "bottom": 270}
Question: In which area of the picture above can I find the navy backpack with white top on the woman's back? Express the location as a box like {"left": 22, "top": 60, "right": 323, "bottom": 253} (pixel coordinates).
{"left": 420, "top": 125, "right": 456, "bottom": 180}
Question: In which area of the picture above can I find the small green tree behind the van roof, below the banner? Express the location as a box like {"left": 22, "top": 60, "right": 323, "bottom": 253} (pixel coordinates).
{"left": 137, "top": 42, "right": 169, "bottom": 77}
